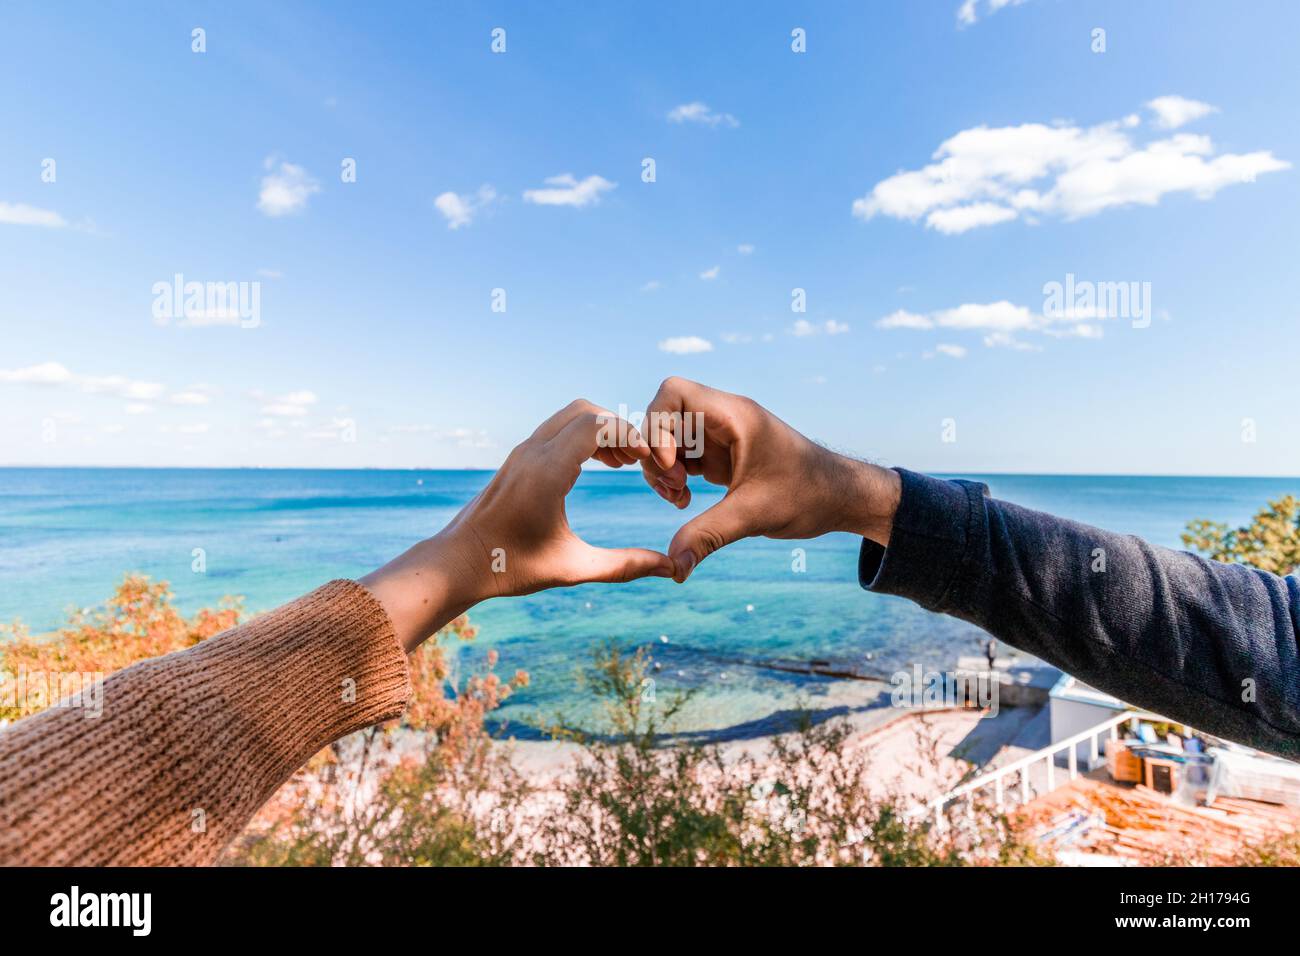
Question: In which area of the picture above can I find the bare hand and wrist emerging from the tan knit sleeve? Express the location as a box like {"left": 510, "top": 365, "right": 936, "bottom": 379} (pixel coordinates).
{"left": 361, "top": 399, "right": 673, "bottom": 652}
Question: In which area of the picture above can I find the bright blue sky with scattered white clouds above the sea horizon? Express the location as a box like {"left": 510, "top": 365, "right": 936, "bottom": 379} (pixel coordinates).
{"left": 0, "top": 0, "right": 1300, "bottom": 475}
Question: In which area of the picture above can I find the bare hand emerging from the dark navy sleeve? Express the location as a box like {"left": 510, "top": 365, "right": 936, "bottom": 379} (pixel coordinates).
{"left": 641, "top": 378, "right": 901, "bottom": 583}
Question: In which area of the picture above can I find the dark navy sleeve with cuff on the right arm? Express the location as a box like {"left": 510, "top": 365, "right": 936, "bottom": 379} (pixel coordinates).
{"left": 858, "top": 468, "right": 1300, "bottom": 758}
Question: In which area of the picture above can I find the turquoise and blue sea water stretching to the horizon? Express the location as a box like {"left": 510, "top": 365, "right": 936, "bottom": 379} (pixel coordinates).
{"left": 0, "top": 468, "right": 1300, "bottom": 736}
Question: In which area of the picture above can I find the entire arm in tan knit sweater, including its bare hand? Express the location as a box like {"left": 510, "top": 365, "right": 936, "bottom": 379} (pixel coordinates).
{"left": 0, "top": 402, "right": 672, "bottom": 865}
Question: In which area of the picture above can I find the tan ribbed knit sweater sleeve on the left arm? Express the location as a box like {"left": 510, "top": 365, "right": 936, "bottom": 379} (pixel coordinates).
{"left": 0, "top": 580, "right": 411, "bottom": 866}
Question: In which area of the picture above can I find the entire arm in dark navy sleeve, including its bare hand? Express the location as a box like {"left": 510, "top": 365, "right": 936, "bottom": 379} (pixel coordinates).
{"left": 642, "top": 378, "right": 1300, "bottom": 758}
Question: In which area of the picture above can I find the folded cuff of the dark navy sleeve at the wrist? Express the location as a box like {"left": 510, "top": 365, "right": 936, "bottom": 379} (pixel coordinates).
{"left": 858, "top": 468, "right": 988, "bottom": 610}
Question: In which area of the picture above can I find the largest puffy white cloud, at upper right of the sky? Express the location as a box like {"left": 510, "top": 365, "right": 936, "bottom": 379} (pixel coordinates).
{"left": 853, "top": 98, "right": 1291, "bottom": 234}
